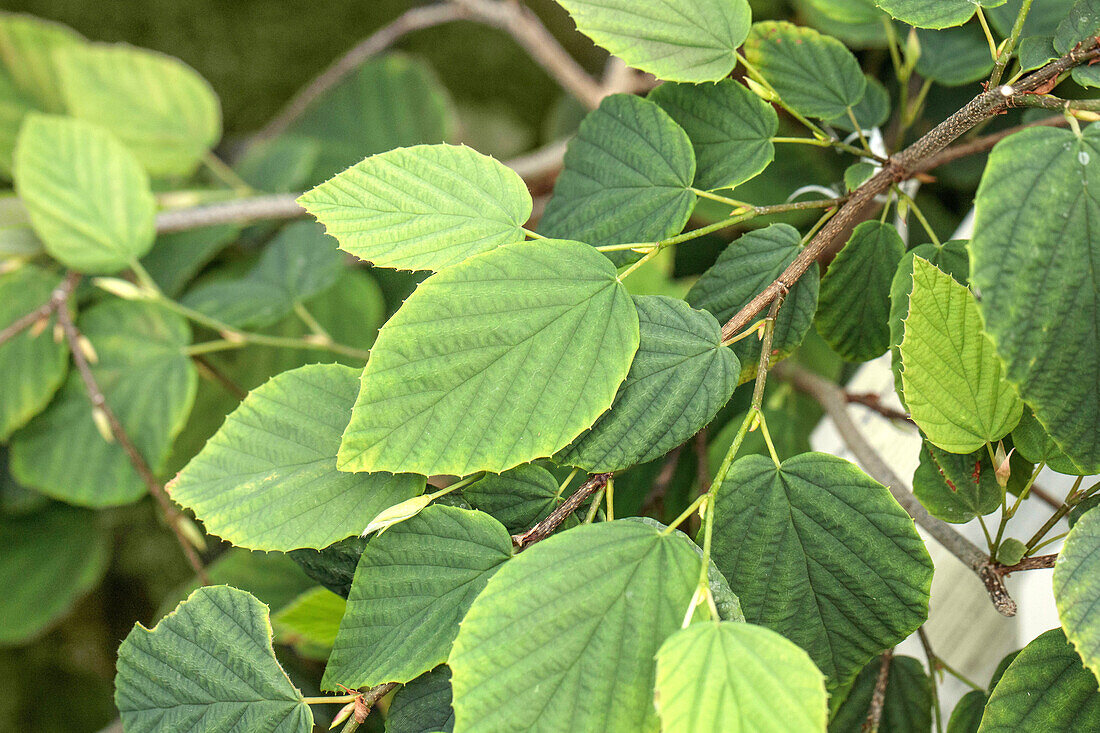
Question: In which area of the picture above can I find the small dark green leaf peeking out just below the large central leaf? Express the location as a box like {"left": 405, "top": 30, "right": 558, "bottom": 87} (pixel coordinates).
{"left": 462, "top": 463, "right": 565, "bottom": 535}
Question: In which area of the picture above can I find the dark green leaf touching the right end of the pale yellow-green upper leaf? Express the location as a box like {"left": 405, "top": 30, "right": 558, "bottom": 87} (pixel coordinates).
{"left": 539, "top": 95, "right": 696, "bottom": 247}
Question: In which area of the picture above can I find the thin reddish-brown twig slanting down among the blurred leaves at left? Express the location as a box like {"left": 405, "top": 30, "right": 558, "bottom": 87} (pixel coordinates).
{"left": 57, "top": 290, "right": 210, "bottom": 586}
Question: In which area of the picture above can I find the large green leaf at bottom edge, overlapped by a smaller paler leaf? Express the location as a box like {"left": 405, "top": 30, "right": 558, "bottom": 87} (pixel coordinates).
{"left": 448, "top": 521, "right": 700, "bottom": 733}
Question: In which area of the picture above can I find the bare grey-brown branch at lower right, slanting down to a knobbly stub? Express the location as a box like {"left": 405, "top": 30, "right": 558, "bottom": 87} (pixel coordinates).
{"left": 772, "top": 362, "right": 1016, "bottom": 616}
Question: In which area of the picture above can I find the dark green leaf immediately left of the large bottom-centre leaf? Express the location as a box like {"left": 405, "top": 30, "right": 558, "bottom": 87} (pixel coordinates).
{"left": 321, "top": 505, "right": 512, "bottom": 690}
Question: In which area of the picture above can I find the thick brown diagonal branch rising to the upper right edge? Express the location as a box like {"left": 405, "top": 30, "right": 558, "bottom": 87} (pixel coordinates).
{"left": 722, "top": 39, "right": 1100, "bottom": 341}
